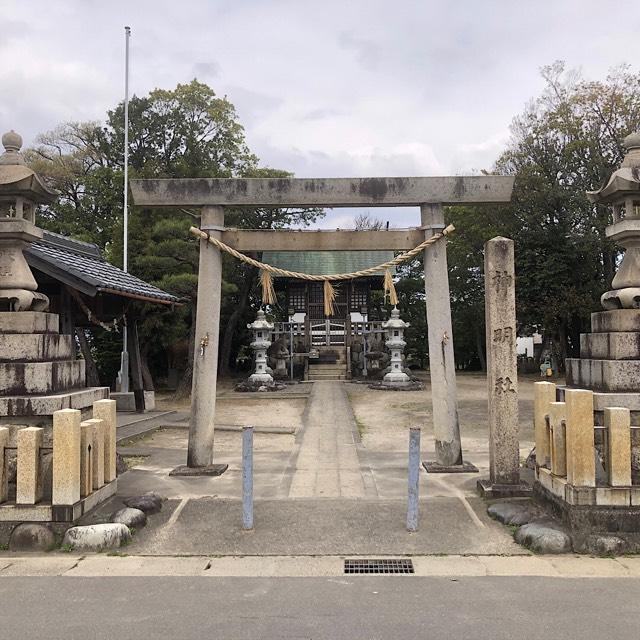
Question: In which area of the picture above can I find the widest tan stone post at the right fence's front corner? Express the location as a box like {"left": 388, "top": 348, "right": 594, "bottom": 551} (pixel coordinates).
{"left": 565, "top": 389, "right": 596, "bottom": 487}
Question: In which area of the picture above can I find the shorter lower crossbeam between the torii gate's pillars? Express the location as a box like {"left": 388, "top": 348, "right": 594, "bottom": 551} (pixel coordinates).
{"left": 222, "top": 229, "right": 424, "bottom": 251}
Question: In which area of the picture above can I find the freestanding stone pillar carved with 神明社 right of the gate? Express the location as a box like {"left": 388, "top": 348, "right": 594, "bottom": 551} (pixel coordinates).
{"left": 484, "top": 237, "right": 520, "bottom": 485}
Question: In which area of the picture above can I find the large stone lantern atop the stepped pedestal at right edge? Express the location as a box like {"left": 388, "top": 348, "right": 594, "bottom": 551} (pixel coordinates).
{"left": 587, "top": 133, "right": 640, "bottom": 310}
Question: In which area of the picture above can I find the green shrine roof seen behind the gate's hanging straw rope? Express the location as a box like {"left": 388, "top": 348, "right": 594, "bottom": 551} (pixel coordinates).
{"left": 262, "top": 251, "right": 394, "bottom": 278}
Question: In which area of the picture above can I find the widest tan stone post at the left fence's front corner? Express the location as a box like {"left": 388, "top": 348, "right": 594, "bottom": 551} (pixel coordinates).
{"left": 51, "top": 409, "right": 81, "bottom": 505}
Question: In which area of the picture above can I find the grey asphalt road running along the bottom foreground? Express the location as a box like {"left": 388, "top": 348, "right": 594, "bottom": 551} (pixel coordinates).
{"left": 0, "top": 576, "right": 640, "bottom": 640}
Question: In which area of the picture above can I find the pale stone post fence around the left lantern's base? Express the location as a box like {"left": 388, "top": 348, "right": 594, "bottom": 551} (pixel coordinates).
{"left": 0, "top": 400, "right": 116, "bottom": 522}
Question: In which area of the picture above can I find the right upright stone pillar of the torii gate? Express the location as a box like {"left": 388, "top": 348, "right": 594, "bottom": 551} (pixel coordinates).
{"left": 420, "top": 204, "right": 462, "bottom": 467}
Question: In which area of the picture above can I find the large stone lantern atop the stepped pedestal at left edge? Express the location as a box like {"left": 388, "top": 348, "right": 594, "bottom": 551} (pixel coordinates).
{"left": 0, "top": 131, "right": 56, "bottom": 311}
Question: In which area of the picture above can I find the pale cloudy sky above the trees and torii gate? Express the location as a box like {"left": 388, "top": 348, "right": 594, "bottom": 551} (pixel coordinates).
{"left": 0, "top": 0, "right": 640, "bottom": 228}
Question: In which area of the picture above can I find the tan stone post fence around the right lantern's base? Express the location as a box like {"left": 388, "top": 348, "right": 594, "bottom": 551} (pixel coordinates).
{"left": 534, "top": 382, "right": 640, "bottom": 507}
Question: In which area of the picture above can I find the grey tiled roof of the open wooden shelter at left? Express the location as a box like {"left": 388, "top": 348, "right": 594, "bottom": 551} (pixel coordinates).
{"left": 24, "top": 231, "right": 180, "bottom": 304}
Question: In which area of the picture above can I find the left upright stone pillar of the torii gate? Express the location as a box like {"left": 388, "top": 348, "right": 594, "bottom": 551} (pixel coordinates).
{"left": 187, "top": 207, "right": 224, "bottom": 467}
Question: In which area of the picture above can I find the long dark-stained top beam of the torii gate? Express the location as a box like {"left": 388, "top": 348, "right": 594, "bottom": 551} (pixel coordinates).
{"left": 130, "top": 176, "right": 514, "bottom": 207}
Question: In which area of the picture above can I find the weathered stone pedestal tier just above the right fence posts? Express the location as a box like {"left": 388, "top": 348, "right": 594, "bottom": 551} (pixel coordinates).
{"left": 566, "top": 358, "right": 640, "bottom": 393}
